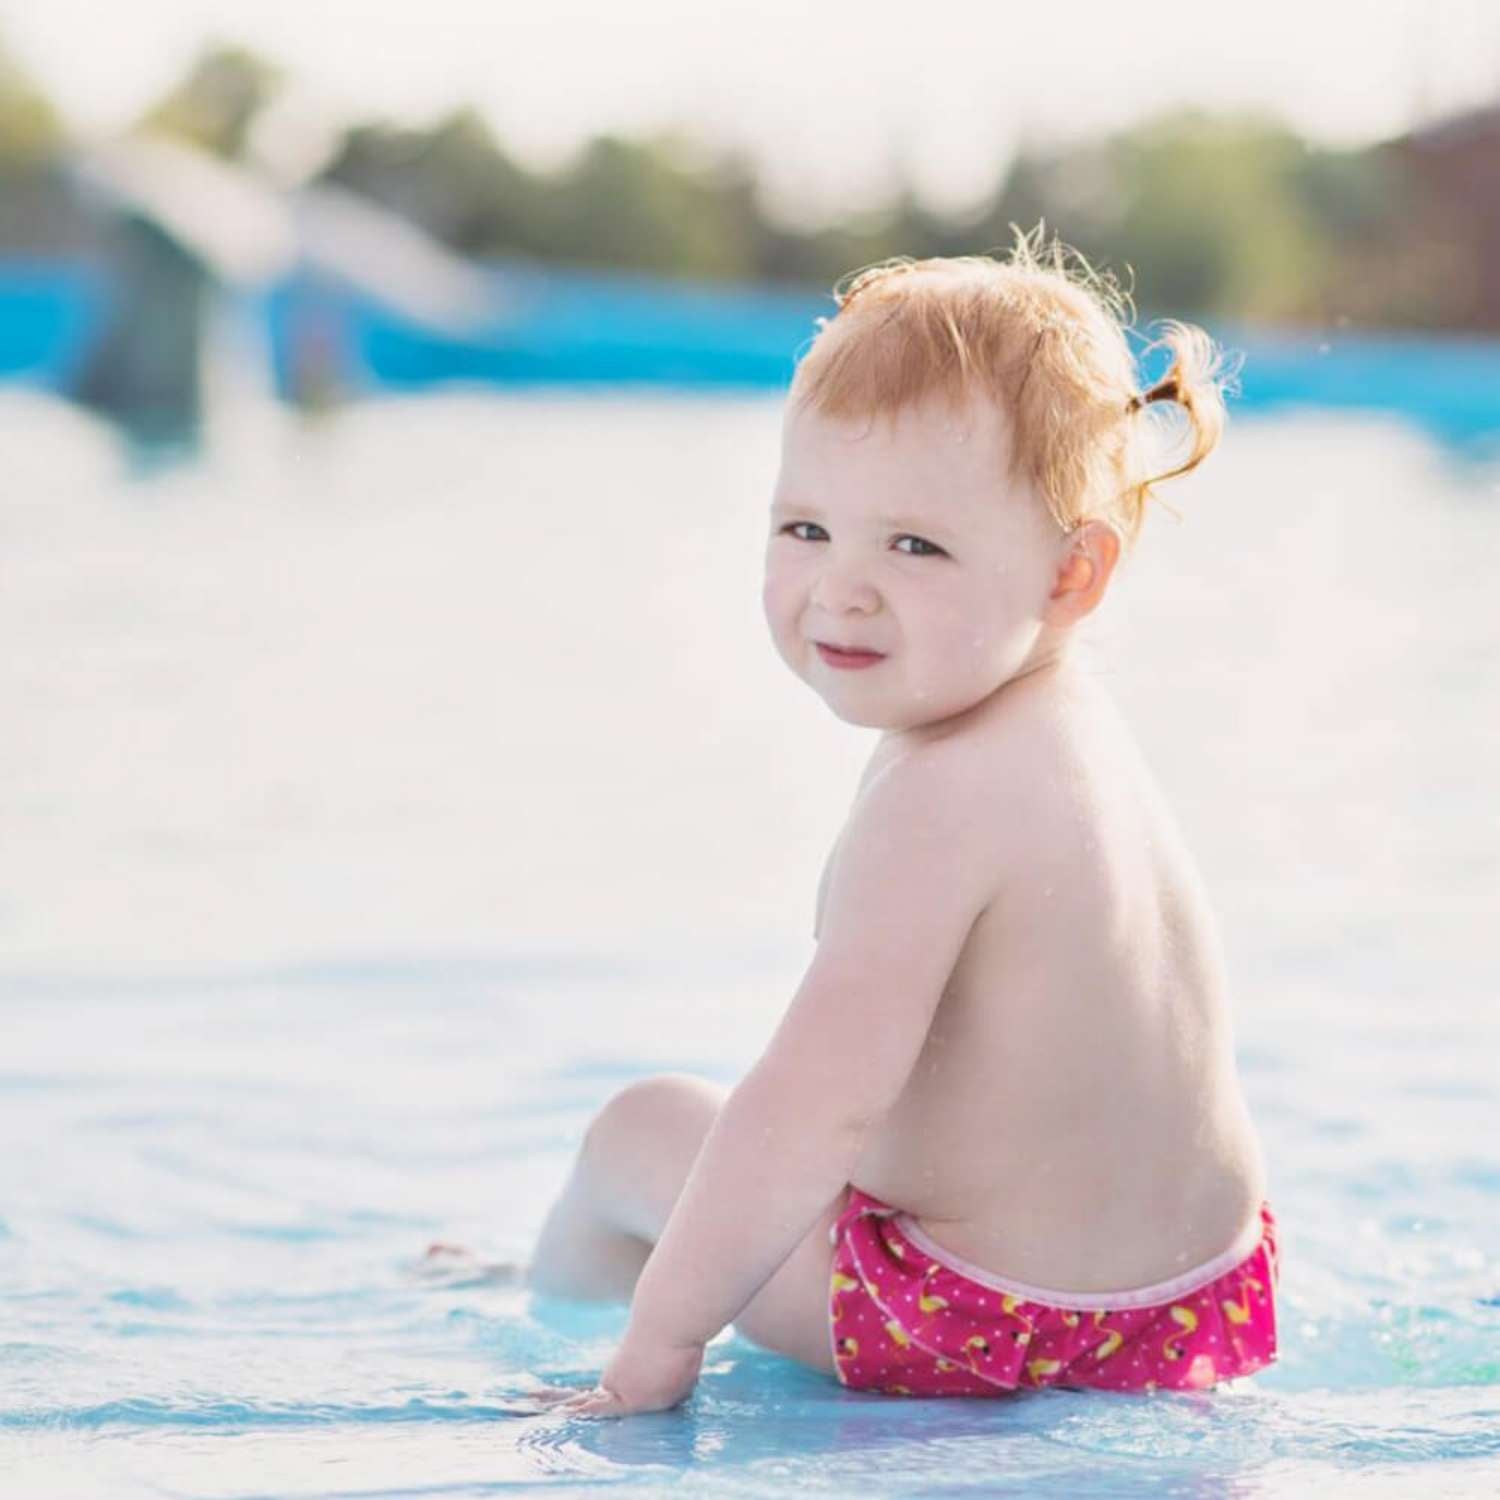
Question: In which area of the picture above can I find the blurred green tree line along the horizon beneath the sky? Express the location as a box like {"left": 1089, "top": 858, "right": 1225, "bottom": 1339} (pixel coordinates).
{"left": 0, "top": 34, "right": 1500, "bottom": 327}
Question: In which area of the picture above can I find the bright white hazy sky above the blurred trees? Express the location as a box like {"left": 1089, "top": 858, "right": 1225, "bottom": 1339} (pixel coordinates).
{"left": 0, "top": 0, "right": 1500, "bottom": 228}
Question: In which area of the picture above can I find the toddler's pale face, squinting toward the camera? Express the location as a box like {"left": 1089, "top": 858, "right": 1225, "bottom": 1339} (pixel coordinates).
{"left": 762, "top": 402, "right": 1068, "bottom": 731}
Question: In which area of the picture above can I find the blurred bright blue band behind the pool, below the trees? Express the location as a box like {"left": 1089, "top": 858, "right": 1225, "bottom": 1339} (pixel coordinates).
{"left": 0, "top": 263, "right": 1500, "bottom": 450}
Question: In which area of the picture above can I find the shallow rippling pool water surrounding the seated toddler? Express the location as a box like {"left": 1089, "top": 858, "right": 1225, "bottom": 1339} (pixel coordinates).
{"left": 0, "top": 396, "right": 1500, "bottom": 1500}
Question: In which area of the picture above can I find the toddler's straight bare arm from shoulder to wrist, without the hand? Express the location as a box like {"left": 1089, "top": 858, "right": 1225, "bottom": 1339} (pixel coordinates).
{"left": 609, "top": 747, "right": 995, "bottom": 1358}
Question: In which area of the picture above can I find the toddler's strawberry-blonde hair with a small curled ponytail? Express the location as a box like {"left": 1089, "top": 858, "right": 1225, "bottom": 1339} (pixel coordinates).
{"left": 791, "top": 222, "right": 1233, "bottom": 549}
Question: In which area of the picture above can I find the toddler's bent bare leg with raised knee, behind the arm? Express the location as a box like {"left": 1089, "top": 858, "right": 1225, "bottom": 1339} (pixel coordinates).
{"left": 527, "top": 1073, "right": 728, "bottom": 1302}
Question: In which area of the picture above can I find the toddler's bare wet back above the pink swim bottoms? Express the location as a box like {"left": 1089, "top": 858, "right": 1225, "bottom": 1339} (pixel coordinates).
{"left": 819, "top": 672, "right": 1265, "bottom": 1292}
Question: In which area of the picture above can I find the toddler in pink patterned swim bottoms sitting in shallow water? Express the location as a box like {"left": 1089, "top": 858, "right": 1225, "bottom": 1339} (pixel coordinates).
{"left": 527, "top": 228, "right": 1277, "bottom": 1416}
